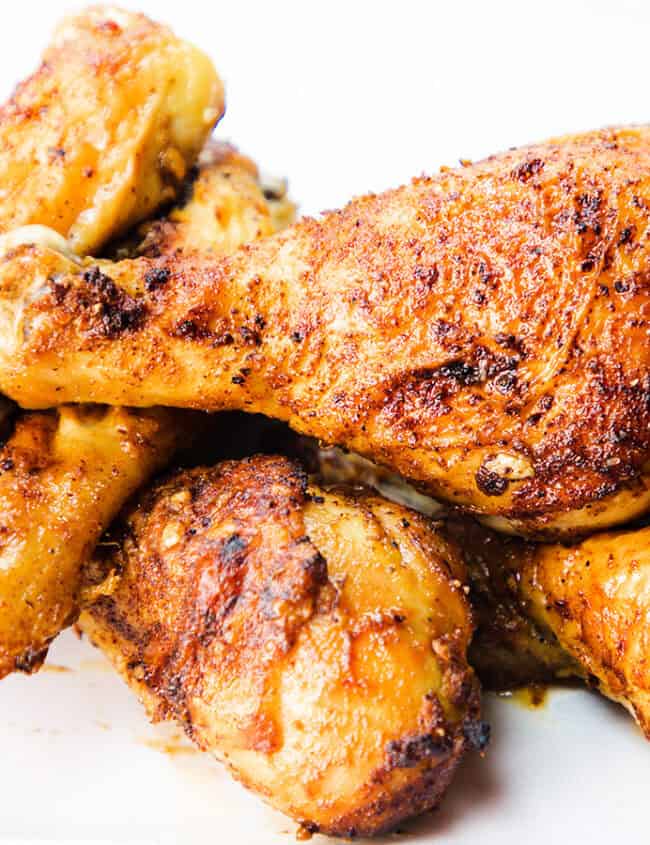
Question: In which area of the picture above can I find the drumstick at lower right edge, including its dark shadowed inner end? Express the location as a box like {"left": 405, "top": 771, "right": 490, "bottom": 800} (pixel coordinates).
{"left": 454, "top": 519, "right": 650, "bottom": 739}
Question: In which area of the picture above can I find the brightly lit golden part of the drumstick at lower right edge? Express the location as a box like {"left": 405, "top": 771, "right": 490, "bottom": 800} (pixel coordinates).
{"left": 498, "top": 528, "right": 650, "bottom": 739}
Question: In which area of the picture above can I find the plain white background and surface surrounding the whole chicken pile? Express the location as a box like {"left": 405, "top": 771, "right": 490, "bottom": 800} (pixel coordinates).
{"left": 0, "top": 0, "right": 650, "bottom": 845}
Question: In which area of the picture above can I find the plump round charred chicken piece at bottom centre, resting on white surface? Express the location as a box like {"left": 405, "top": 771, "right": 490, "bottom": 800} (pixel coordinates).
{"left": 81, "top": 456, "right": 486, "bottom": 835}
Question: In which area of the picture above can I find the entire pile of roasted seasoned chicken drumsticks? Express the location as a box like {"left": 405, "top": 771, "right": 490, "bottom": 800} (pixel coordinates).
{"left": 0, "top": 8, "right": 650, "bottom": 835}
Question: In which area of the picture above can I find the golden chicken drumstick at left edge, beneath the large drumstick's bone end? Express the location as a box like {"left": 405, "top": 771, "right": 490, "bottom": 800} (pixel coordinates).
{"left": 0, "top": 406, "right": 187, "bottom": 678}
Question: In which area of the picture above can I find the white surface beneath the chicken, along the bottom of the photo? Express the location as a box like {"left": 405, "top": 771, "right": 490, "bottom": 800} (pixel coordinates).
{"left": 0, "top": 632, "right": 650, "bottom": 845}
